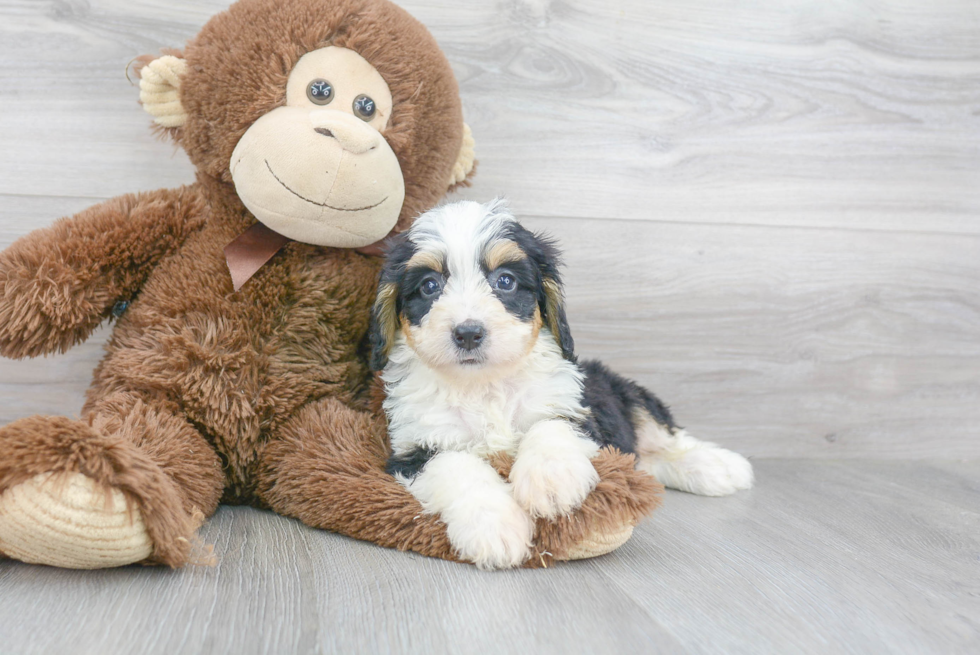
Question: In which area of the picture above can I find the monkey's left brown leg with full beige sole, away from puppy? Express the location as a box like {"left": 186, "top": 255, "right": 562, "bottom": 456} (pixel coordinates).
{"left": 0, "top": 393, "right": 224, "bottom": 568}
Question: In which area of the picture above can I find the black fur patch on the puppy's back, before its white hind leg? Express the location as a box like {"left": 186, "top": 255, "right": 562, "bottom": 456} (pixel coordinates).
{"left": 579, "top": 360, "right": 677, "bottom": 453}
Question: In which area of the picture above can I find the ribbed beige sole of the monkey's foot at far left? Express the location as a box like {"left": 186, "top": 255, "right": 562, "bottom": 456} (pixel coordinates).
{"left": 0, "top": 473, "right": 153, "bottom": 569}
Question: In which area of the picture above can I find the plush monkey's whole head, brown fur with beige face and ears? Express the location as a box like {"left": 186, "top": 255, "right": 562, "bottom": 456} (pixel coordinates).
{"left": 140, "top": 0, "right": 474, "bottom": 248}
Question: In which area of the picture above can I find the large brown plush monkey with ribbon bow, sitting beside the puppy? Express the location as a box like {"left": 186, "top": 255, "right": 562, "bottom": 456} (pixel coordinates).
{"left": 0, "top": 0, "right": 659, "bottom": 568}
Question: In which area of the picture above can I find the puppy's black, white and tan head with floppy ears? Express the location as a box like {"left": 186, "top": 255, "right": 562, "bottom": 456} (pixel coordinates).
{"left": 371, "top": 200, "right": 575, "bottom": 371}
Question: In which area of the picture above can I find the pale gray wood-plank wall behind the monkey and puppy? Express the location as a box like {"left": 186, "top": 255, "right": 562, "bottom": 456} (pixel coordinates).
{"left": 0, "top": 6, "right": 980, "bottom": 457}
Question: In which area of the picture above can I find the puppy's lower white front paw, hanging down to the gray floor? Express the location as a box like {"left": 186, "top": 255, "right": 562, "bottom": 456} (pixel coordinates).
{"left": 444, "top": 496, "right": 534, "bottom": 569}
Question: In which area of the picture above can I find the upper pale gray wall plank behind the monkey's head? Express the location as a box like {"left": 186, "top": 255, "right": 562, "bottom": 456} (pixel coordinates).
{"left": 0, "top": 0, "right": 980, "bottom": 234}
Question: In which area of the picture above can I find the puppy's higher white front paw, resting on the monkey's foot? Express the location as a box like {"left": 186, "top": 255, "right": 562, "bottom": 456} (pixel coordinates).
{"left": 510, "top": 421, "right": 599, "bottom": 519}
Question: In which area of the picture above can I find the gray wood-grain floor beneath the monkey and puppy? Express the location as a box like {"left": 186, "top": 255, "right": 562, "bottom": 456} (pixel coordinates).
{"left": 0, "top": 460, "right": 980, "bottom": 655}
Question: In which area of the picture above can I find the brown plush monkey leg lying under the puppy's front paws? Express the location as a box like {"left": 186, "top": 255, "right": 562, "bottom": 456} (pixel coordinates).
{"left": 258, "top": 399, "right": 663, "bottom": 567}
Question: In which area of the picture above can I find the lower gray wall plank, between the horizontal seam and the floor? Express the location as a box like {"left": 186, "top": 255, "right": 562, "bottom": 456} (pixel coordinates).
{"left": 0, "top": 198, "right": 980, "bottom": 458}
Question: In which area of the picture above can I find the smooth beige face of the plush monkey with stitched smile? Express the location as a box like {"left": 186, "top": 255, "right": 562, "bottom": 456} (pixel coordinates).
{"left": 230, "top": 46, "right": 405, "bottom": 248}
